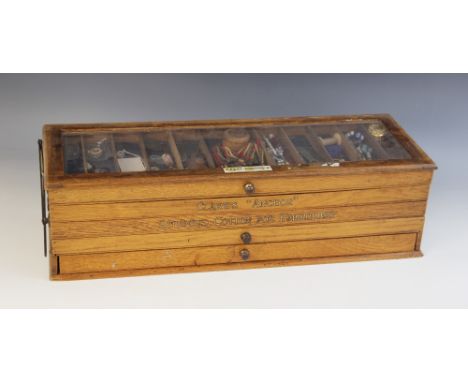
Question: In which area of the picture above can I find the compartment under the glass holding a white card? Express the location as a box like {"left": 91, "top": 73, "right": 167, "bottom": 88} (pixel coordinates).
{"left": 113, "top": 133, "right": 148, "bottom": 172}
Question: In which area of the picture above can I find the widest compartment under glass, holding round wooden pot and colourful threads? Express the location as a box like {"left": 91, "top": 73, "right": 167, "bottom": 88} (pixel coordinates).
{"left": 202, "top": 128, "right": 270, "bottom": 167}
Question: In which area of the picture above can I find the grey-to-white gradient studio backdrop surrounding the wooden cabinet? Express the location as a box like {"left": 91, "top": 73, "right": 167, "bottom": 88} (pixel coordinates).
{"left": 0, "top": 74, "right": 468, "bottom": 308}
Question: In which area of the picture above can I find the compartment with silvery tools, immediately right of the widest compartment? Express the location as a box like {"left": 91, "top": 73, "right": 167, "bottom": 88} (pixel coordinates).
{"left": 256, "top": 128, "right": 304, "bottom": 166}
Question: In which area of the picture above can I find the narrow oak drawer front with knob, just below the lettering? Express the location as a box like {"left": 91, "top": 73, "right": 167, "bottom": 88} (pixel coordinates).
{"left": 52, "top": 217, "right": 424, "bottom": 255}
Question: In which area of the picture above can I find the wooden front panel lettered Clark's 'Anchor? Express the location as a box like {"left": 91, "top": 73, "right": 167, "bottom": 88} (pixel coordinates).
{"left": 49, "top": 185, "right": 429, "bottom": 223}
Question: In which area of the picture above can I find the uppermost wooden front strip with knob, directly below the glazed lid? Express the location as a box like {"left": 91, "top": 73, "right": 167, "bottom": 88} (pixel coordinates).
{"left": 48, "top": 171, "right": 432, "bottom": 204}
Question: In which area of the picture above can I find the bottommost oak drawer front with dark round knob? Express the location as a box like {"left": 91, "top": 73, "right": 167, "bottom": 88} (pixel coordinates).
{"left": 59, "top": 233, "right": 417, "bottom": 274}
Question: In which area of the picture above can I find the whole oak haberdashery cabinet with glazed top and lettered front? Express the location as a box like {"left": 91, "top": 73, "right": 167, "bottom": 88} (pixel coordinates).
{"left": 40, "top": 115, "right": 436, "bottom": 280}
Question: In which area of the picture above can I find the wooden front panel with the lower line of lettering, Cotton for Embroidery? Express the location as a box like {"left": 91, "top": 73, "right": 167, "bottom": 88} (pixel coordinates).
{"left": 50, "top": 201, "right": 426, "bottom": 240}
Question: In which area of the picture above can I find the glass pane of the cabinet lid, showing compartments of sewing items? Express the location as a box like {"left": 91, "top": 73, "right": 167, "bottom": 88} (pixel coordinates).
{"left": 62, "top": 121, "right": 411, "bottom": 174}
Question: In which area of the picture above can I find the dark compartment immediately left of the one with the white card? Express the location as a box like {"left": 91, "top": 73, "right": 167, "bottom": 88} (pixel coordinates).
{"left": 83, "top": 134, "right": 116, "bottom": 173}
